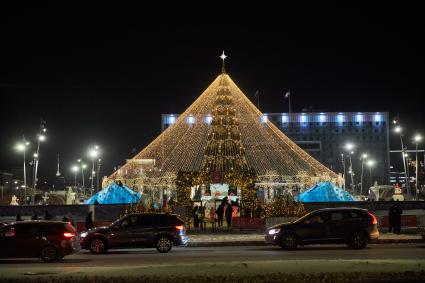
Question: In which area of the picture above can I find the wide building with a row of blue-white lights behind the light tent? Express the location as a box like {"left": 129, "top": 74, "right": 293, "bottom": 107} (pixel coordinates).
{"left": 161, "top": 112, "right": 390, "bottom": 193}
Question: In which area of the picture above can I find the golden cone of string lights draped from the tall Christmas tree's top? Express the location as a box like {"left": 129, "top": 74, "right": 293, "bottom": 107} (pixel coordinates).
{"left": 104, "top": 70, "right": 341, "bottom": 197}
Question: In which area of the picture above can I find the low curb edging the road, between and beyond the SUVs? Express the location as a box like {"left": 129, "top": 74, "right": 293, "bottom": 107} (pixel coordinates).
{"left": 187, "top": 239, "right": 425, "bottom": 248}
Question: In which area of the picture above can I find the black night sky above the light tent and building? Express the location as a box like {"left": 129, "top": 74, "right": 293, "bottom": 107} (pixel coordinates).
{"left": 0, "top": 1, "right": 425, "bottom": 185}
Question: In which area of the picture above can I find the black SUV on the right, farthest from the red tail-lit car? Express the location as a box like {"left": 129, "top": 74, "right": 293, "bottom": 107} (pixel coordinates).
{"left": 265, "top": 208, "right": 379, "bottom": 250}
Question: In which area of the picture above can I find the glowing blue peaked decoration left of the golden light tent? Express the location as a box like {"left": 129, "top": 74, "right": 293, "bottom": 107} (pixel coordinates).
{"left": 85, "top": 183, "right": 142, "bottom": 204}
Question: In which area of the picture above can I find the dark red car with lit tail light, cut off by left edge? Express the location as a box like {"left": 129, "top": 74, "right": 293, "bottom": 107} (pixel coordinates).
{"left": 0, "top": 220, "right": 80, "bottom": 262}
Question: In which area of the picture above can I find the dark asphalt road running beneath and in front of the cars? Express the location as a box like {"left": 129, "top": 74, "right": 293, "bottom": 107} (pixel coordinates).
{"left": 0, "top": 243, "right": 425, "bottom": 269}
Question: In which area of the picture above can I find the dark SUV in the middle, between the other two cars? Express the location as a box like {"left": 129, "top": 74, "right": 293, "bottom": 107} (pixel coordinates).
{"left": 80, "top": 213, "right": 188, "bottom": 254}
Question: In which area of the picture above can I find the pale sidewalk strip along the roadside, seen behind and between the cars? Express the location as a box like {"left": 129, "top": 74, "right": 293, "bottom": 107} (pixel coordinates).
{"left": 188, "top": 232, "right": 424, "bottom": 247}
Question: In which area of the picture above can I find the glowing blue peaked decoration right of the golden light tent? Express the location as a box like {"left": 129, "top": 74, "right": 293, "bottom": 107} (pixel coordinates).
{"left": 295, "top": 182, "right": 355, "bottom": 202}
